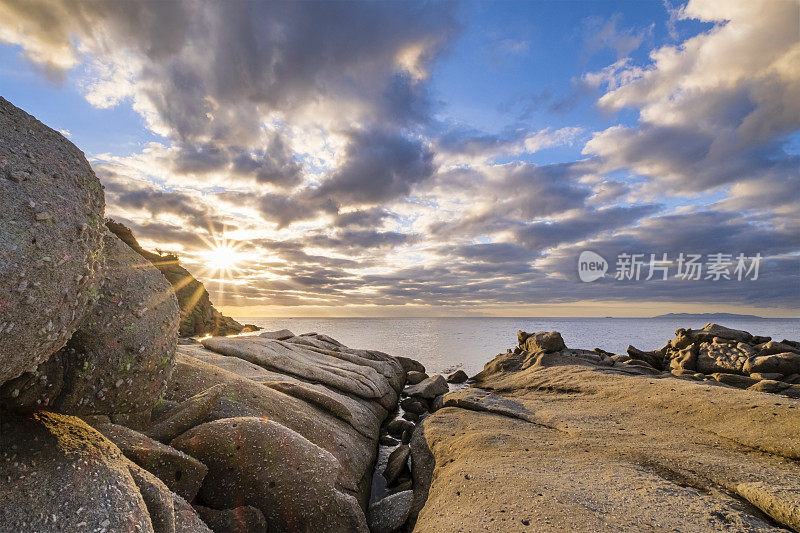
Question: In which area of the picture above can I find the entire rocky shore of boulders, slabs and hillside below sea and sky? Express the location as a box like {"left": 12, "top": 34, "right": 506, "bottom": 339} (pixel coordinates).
{"left": 0, "top": 98, "right": 800, "bottom": 533}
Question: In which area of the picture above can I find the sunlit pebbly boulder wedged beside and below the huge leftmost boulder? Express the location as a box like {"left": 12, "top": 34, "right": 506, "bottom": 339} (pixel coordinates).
{"left": 55, "top": 233, "right": 179, "bottom": 414}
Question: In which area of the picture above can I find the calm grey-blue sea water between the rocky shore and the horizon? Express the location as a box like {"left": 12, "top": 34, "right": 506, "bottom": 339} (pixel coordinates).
{"left": 238, "top": 317, "right": 800, "bottom": 376}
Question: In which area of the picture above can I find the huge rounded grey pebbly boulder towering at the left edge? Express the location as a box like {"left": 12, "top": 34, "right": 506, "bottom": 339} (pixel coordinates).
{"left": 0, "top": 97, "right": 104, "bottom": 383}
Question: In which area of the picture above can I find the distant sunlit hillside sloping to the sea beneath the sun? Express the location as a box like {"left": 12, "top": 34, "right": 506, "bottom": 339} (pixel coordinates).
{"left": 106, "top": 219, "right": 245, "bottom": 337}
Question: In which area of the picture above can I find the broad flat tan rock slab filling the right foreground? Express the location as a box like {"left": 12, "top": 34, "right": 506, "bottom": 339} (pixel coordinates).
{"left": 407, "top": 328, "right": 800, "bottom": 532}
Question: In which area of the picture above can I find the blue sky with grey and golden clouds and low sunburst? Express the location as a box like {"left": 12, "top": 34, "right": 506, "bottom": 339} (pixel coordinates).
{"left": 0, "top": 0, "right": 800, "bottom": 317}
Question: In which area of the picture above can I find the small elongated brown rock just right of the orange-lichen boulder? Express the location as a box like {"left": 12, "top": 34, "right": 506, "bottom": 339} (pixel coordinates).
{"left": 94, "top": 424, "right": 208, "bottom": 501}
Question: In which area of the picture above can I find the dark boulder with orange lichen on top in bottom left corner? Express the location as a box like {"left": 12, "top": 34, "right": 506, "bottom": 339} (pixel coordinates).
{"left": 0, "top": 412, "right": 153, "bottom": 533}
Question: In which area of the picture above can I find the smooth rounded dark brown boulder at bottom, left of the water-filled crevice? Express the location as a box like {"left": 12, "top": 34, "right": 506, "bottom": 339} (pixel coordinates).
{"left": 172, "top": 417, "right": 367, "bottom": 532}
